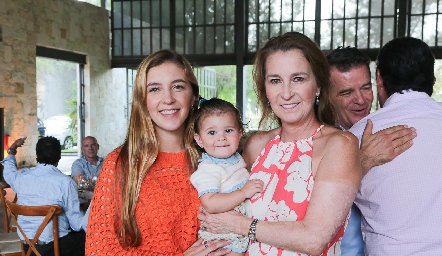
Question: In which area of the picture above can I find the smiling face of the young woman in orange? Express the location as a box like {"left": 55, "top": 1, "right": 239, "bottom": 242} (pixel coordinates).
{"left": 146, "top": 62, "right": 195, "bottom": 137}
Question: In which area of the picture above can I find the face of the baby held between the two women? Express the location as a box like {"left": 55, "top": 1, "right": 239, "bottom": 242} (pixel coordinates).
{"left": 194, "top": 112, "right": 242, "bottom": 158}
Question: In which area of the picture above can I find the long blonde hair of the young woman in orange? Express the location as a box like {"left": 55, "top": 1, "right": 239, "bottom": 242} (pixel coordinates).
{"left": 116, "top": 50, "right": 199, "bottom": 248}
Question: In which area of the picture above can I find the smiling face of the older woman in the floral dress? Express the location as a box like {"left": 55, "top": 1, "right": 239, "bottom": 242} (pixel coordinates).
{"left": 265, "top": 50, "right": 320, "bottom": 125}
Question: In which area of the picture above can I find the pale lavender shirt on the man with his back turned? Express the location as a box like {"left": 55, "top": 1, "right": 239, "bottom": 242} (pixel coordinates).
{"left": 350, "top": 91, "right": 442, "bottom": 255}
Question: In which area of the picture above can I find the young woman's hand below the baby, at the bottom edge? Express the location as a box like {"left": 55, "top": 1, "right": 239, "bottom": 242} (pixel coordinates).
{"left": 184, "top": 238, "right": 231, "bottom": 256}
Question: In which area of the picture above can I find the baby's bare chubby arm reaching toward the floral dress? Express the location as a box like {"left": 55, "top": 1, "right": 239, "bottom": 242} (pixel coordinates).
{"left": 200, "top": 179, "right": 264, "bottom": 214}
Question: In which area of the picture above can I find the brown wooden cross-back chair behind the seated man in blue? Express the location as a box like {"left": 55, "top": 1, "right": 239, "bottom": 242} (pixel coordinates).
{"left": 6, "top": 201, "right": 61, "bottom": 256}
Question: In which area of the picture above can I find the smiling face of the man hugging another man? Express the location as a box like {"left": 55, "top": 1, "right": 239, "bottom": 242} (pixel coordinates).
{"left": 330, "top": 65, "right": 373, "bottom": 129}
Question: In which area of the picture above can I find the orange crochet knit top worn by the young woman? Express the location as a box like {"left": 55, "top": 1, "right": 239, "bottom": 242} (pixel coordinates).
{"left": 86, "top": 149, "right": 200, "bottom": 256}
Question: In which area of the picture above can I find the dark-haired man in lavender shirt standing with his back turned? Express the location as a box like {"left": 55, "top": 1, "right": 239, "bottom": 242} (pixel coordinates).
{"left": 350, "top": 37, "right": 442, "bottom": 256}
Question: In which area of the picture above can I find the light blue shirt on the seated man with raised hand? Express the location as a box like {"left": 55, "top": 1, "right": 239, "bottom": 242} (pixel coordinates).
{"left": 1, "top": 155, "right": 83, "bottom": 243}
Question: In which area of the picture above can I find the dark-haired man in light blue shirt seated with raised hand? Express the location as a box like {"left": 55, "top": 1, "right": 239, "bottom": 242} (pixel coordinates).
{"left": 1, "top": 137, "right": 85, "bottom": 256}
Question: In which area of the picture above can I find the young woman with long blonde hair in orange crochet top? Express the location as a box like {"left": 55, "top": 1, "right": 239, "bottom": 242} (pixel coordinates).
{"left": 86, "top": 50, "right": 230, "bottom": 256}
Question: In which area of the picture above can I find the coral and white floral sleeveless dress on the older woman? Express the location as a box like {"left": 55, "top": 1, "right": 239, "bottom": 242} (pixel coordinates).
{"left": 246, "top": 125, "right": 344, "bottom": 256}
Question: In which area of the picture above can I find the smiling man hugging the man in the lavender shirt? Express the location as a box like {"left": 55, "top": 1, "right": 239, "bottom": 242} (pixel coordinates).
{"left": 327, "top": 47, "right": 415, "bottom": 256}
